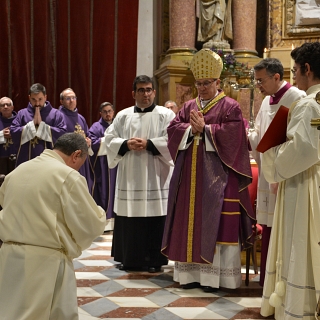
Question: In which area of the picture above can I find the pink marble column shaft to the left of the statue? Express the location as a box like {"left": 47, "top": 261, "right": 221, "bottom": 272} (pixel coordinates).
{"left": 167, "top": 0, "right": 196, "bottom": 54}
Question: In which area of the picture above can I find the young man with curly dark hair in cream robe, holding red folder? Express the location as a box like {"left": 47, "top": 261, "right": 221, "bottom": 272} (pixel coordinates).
{"left": 261, "top": 42, "right": 320, "bottom": 319}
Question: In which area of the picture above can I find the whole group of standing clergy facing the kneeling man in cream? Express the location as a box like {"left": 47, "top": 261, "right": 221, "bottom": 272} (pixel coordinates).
{"left": 0, "top": 42, "right": 320, "bottom": 319}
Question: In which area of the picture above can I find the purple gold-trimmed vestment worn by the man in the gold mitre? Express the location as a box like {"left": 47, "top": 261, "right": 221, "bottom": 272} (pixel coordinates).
{"left": 162, "top": 91, "right": 255, "bottom": 263}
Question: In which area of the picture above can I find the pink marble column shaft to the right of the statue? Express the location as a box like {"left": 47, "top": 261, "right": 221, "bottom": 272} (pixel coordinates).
{"left": 232, "top": 0, "right": 258, "bottom": 58}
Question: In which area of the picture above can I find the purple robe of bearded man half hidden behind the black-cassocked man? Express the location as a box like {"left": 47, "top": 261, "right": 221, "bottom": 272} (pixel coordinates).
{"left": 89, "top": 118, "right": 117, "bottom": 219}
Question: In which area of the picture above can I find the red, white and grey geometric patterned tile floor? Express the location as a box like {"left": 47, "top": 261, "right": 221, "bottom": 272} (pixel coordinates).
{"left": 74, "top": 232, "right": 273, "bottom": 320}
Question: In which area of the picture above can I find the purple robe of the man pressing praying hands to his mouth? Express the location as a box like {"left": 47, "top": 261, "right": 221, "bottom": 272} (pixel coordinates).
{"left": 10, "top": 101, "right": 66, "bottom": 166}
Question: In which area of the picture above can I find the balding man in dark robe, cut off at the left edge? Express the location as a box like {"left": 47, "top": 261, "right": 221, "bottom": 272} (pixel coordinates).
{"left": 0, "top": 97, "right": 17, "bottom": 174}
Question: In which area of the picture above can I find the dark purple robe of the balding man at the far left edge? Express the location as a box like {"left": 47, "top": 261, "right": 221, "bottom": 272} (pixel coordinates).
{"left": 0, "top": 111, "right": 18, "bottom": 174}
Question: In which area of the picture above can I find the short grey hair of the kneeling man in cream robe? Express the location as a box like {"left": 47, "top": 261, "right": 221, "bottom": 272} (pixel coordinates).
{"left": 53, "top": 132, "right": 88, "bottom": 157}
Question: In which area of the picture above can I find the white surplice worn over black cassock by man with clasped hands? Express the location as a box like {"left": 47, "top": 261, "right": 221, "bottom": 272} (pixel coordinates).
{"left": 99, "top": 106, "right": 175, "bottom": 217}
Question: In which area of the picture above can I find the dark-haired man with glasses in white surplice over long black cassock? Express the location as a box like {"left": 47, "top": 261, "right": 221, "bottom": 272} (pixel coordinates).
{"left": 104, "top": 75, "right": 175, "bottom": 273}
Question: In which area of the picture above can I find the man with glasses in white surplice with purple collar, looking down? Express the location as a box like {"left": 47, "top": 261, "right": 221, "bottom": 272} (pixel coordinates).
{"left": 248, "top": 58, "right": 306, "bottom": 286}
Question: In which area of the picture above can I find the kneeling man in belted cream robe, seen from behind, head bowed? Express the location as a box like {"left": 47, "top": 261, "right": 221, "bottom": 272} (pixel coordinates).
{"left": 0, "top": 133, "right": 105, "bottom": 320}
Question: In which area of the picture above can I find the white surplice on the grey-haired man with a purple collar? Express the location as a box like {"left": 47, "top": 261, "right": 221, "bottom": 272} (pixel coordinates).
{"left": 248, "top": 81, "right": 306, "bottom": 227}
